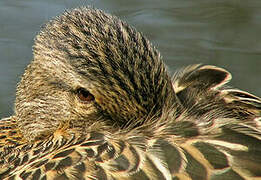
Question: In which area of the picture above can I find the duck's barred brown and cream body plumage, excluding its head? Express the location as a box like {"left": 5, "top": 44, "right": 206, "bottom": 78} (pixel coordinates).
{"left": 0, "top": 66, "right": 261, "bottom": 180}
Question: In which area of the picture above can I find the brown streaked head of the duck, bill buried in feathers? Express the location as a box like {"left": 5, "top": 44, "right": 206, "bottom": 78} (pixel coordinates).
{"left": 15, "top": 8, "right": 175, "bottom": 141}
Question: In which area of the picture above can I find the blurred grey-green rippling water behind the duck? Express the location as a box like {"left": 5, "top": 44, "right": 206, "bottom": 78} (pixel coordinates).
{"left": 0, "top": 0, "right": 261, "bottom": 118}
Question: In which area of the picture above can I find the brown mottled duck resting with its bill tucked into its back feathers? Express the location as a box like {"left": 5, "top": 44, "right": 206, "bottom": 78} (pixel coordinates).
{"left": 0, "top": 7, "right": 261, "bottom": 180}
